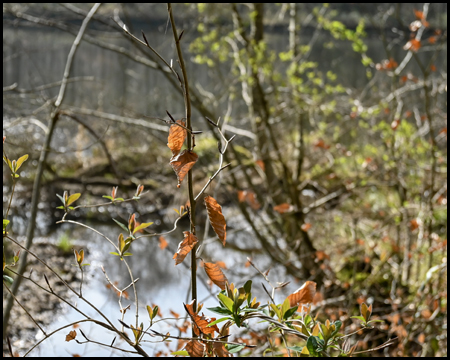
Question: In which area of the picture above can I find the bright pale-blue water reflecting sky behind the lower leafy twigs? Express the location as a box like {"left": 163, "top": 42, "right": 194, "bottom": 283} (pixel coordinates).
{"left": 16, "top": 208, "right": 288, "bottom": 357}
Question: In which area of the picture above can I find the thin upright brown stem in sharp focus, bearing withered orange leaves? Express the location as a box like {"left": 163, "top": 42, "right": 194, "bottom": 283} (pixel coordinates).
{"left": 167, "top": 3, "right": 198, "bottom": 337}
